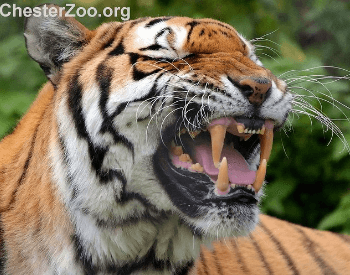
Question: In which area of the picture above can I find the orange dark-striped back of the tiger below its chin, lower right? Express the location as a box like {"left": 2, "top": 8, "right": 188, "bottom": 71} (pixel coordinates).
{"left": 192, "top": 215, "right": 350, "bottom": 275}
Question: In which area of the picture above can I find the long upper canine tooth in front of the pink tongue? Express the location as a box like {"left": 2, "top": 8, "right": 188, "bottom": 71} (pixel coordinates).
{"left": 208, "top": 124, "right": 227, "bottom": 168}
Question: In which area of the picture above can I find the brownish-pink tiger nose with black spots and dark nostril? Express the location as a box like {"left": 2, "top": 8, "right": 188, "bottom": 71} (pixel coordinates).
{"left": 239, "top": 78, "right": 272, "bottom": 105}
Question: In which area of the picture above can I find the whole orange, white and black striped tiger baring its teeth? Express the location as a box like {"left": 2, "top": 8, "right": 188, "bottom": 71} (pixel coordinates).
{"left": 0, "top": 5, "right": 350, "bottom": 275}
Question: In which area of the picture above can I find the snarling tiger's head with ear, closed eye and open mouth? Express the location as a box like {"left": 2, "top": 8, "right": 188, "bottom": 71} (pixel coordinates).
{"left": 25, "top": 4, "right": 292, "bottom": 242}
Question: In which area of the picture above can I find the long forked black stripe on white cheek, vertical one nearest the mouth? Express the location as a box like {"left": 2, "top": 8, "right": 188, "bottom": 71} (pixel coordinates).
{"left": 96, "top": 62, "right": 135, "bottom": 157}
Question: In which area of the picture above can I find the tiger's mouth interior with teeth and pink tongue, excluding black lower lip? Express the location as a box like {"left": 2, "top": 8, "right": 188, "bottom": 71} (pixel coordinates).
{"left": 170, "top": 117, "right": 274, "bottom": 196}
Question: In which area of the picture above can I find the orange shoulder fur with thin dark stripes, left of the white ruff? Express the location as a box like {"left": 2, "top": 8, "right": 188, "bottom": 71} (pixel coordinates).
{"left": 0, "top": 83, "right": 72, "bottom": 274}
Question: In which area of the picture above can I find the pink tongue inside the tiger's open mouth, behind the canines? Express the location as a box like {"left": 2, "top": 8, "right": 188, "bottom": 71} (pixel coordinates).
{"left": 196, "top": 144, "right": 256, "bottom": 185}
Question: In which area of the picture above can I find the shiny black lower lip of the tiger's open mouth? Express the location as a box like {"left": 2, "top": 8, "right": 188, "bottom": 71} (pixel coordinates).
{"left": 153, "top": 145, "right": 258, "bottom": 220}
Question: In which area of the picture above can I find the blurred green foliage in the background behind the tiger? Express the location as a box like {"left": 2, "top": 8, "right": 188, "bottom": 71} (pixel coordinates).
{"left": 0, "top": 0, "right": 350, "bottom": 233}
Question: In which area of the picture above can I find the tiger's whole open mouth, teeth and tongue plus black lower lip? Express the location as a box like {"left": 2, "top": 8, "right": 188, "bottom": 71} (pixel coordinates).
{"left": 153, "top": 117, "right": 274, "bottom": 217}
